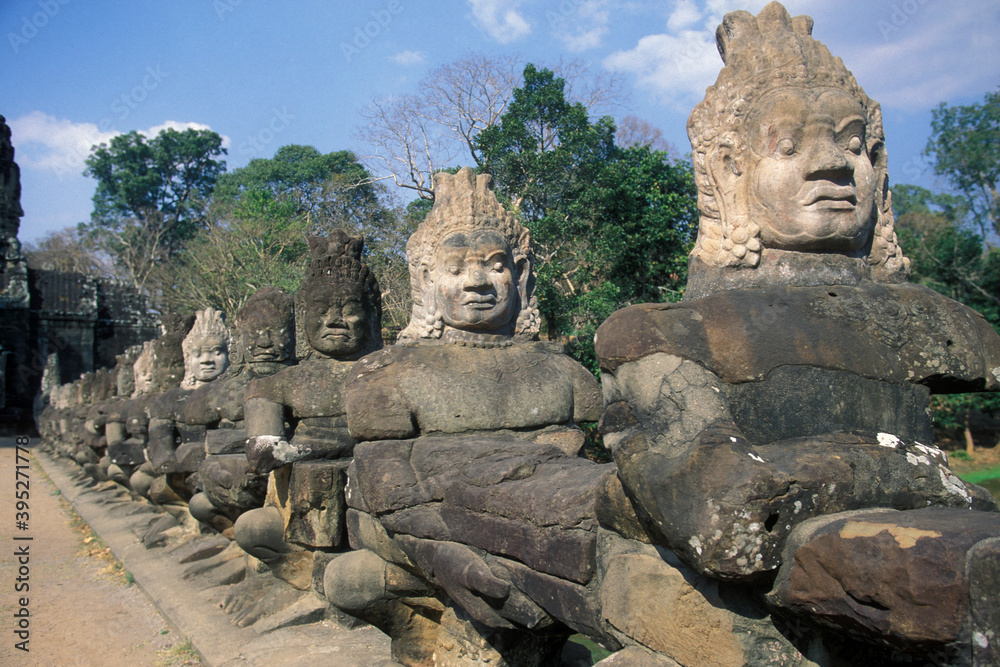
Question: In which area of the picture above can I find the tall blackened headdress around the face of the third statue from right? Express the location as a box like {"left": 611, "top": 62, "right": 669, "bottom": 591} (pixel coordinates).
{"left": 295, "top": 229, "right": 382, "bottom": 359}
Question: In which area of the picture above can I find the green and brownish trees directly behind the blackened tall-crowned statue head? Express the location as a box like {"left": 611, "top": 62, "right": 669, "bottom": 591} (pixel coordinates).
{"left": 158, "top": 145, "right": 415, "bottom": 328}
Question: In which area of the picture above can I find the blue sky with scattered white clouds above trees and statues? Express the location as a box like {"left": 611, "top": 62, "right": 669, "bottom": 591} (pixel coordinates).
{"left": 0, "top": 0, "right": 1000, "bottom": 241}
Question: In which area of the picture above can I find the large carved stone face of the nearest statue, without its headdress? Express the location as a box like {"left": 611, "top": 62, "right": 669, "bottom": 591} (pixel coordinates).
{"left": 740, "top": 88, "right": 876, "bottom": 252}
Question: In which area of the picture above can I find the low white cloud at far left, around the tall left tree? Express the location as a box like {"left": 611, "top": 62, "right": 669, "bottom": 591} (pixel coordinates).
{"left": 8, "top": 111, "right": 231, "bottom": 179}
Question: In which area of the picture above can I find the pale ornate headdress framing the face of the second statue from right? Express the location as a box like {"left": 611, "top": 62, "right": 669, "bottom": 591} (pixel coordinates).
{"left": 399, "top": 167, "right": 540, "bottom": 341}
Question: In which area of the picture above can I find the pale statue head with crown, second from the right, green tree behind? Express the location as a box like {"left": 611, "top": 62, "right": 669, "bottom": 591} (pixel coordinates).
{"left": 400, "top": 167, "right": 539, "bottom": 341}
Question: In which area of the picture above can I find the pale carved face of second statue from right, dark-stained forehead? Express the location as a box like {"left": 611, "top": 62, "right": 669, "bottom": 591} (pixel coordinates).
{"left": 426, "top": 231, "right": 518, "bottom": 332}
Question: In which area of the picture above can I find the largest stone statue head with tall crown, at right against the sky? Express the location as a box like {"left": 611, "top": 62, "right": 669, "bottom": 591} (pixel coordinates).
{"left": 688, "top": 2, "right": 908, "bottom": 282}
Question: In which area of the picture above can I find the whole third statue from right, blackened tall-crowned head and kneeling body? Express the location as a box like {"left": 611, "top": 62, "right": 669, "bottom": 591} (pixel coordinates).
{"left": 235, "top": 230, "right": 382, "bottom": 588}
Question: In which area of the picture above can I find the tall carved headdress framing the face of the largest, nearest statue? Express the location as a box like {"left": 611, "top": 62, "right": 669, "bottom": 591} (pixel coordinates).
{"left": 687, "top": 2, "right": 909, "bottom": 282}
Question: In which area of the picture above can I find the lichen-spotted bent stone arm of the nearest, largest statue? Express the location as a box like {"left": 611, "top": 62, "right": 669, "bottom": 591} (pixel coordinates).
{"left": 602, "top": 353, "right": 789, "bottom": 579}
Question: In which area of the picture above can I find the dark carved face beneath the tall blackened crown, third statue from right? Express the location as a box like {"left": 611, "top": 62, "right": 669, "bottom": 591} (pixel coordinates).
{"left": 305, "top": 283, "right": 367, "bottom": 357}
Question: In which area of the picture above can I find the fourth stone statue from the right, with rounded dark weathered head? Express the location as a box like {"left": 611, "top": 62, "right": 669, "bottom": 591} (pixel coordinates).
{"left": 182, "top": 287, "right": 295, "bottom": 527}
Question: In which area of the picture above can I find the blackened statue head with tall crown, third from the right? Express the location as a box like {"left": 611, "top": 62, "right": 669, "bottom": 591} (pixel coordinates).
{"left": 295, "top": 229, "right": 382, "bottom": 361}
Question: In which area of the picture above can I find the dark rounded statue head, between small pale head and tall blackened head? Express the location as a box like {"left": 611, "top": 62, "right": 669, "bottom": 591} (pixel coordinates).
{"left": 229, "top": 287, "right": 295, "bottom": 375}
